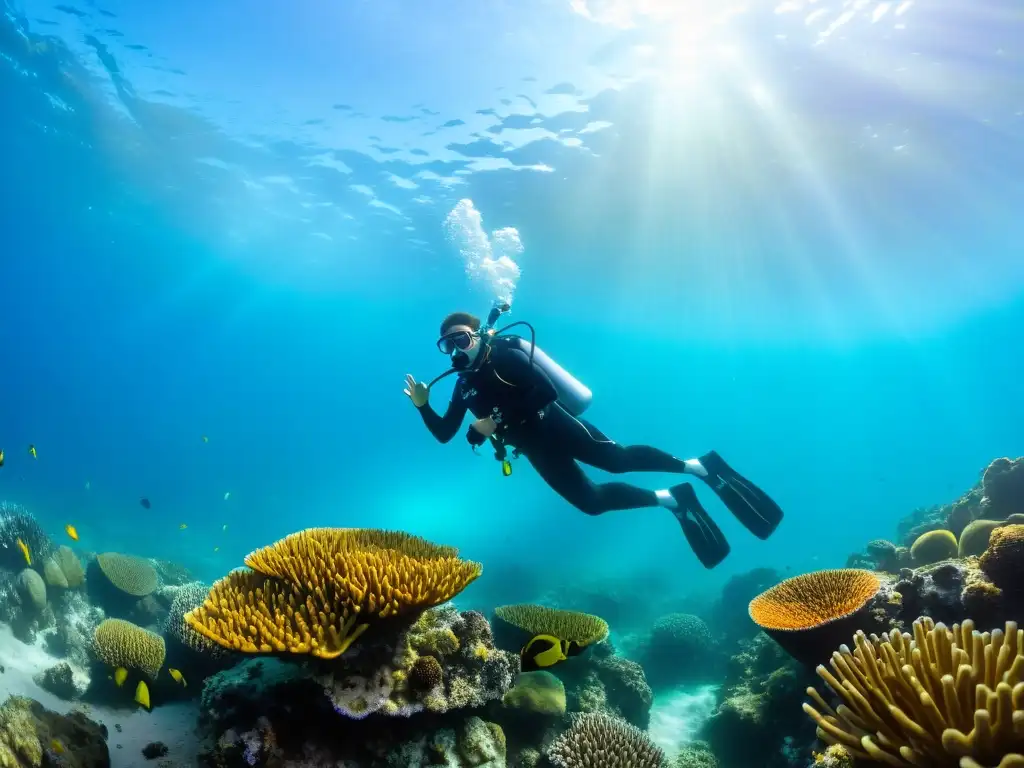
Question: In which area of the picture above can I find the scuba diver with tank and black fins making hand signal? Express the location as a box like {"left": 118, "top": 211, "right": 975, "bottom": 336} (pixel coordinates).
{"left": 403, "top": 304, "right": 782, "bottom": 568}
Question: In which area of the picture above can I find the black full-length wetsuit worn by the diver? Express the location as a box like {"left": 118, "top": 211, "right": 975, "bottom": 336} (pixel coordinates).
{"left": 420, "top": 340, "right": 686, "bottom": 515}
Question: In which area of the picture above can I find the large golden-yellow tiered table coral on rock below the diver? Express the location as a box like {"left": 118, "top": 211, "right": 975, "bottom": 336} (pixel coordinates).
{"left": 185, "top": 528, "right": 482, "bottom": 658}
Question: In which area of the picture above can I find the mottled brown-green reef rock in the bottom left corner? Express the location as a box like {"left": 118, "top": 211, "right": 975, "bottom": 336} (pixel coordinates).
{"left": 0, "top": 696, "right": 111, "bottom": 768}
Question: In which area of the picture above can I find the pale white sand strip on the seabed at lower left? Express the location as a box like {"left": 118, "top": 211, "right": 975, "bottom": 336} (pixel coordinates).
{"left": 0, "top": 625, "right": 199, "bottom": 768}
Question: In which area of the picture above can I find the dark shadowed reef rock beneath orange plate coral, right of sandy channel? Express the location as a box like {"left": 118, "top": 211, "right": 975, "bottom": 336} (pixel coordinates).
{"left": 700, "top": 634, "right": 814, "bottom": 768}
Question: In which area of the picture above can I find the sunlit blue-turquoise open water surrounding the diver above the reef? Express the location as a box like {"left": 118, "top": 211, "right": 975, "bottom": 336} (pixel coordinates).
{"left": 0, "top": 0, "right": 1024, "bottom": 614}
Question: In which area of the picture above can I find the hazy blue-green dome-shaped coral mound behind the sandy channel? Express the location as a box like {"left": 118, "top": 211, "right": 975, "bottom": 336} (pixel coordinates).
{"left": 640, "top": 613, "right": 721, "bottom": 689}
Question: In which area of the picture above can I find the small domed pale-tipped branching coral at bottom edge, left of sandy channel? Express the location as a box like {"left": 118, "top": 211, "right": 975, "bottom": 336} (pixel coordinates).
{"left": 548, "top": 712, "right": 666, "bottom": 768}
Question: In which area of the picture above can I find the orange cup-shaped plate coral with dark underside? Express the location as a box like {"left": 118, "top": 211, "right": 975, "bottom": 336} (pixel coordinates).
{"left": 749, "top": 568, "right": 882, "bottom": 665}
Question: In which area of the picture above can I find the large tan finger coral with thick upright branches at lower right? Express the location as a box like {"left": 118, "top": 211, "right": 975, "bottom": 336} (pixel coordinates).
{"left": 804, "top": 617, "right": 1024, "bottom": 768}
